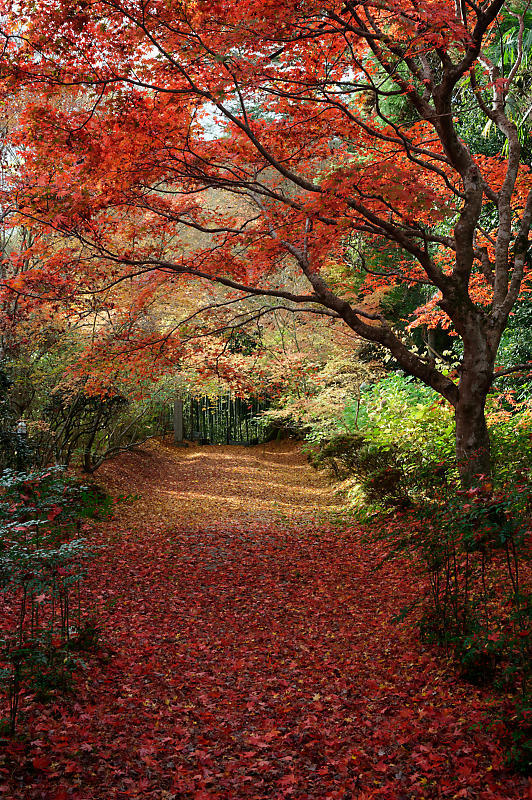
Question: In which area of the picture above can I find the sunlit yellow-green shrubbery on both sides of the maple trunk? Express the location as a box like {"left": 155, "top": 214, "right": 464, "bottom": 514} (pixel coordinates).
{"left": 311, "top": 373, "right": 532, "bottom": 506}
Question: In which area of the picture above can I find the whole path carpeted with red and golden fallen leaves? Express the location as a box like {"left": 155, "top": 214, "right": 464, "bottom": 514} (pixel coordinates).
{"left": 0, "top": 444, "right": 527, "bottom": 800}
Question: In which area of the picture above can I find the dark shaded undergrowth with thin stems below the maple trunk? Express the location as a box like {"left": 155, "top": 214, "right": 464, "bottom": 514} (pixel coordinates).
{"left": 350, "top": 482, "right": 532, "bottom": 775}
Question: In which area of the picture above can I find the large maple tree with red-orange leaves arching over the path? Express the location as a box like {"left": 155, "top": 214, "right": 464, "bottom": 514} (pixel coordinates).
{"left": 2, "top": 0, "right": 532, "bottom": 484}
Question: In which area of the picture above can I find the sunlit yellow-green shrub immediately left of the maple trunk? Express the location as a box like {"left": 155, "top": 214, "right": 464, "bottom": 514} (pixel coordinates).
{"left": 311, "top": 374, "right": 457, "bottom": 508}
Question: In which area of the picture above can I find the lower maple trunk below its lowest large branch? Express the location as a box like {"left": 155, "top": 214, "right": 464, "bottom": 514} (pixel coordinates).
{"left": 455, "top": 397, "right": 491, "bottom": 489}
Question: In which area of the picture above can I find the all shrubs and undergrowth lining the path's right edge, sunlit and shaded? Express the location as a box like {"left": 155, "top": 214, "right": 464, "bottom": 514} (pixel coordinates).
{"left": 307, "top": 375, "right": 532, "bottom": 774}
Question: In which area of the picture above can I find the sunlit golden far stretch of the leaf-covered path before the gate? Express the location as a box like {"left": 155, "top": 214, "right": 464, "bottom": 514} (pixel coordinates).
{"left": 98, "top": 442, "right": 339, "bottom": 527}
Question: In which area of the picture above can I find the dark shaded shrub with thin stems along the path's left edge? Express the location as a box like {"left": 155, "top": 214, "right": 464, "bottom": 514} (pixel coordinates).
{"left": 0, "top": 468, "right": 105, "bottom": 733}
